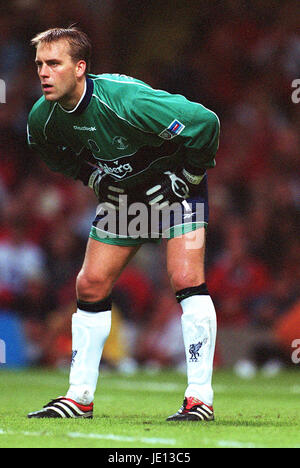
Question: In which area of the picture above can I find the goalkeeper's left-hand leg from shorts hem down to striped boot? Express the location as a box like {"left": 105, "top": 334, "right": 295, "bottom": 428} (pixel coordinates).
{"left": 28, "top": 238, "right": 139, "bottom": 418}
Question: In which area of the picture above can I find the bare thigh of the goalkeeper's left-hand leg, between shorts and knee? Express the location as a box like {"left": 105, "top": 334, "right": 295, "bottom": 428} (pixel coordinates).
{"left": 79, "top": 238, "right": 139, "bottom": 283}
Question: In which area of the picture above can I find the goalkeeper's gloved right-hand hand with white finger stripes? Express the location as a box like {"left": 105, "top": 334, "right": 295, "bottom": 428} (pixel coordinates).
{"left": 145, "top": 169, "right": 205, "bottom": 209}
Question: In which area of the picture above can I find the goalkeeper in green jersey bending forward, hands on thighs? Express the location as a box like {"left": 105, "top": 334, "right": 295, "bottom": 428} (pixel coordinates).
{"left": 28, "top": 27, "right": 220, "bottom": 421}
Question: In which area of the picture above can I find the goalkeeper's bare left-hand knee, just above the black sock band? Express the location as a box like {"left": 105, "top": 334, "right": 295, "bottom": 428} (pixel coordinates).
{"left": 76, "top": 270, "right": 112, "bottom": 302}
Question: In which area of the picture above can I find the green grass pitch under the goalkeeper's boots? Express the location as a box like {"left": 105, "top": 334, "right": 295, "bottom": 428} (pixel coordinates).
{"left": 0, "top": 367, "right": 300, "bottom": 449}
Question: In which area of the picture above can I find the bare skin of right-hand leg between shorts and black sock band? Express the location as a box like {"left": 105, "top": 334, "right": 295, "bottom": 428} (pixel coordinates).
{"left": 167, "top": 227, "right": 205, "bottom": 291}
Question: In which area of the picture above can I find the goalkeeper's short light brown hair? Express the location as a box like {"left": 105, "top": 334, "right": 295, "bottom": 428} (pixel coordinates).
{"left": 31, "top": 26, "right": 92, "bottom": 72}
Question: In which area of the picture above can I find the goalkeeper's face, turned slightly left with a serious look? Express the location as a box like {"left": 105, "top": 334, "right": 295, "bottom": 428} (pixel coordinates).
{"left": 35, "top": 39, "right": 82, "bottom": 104}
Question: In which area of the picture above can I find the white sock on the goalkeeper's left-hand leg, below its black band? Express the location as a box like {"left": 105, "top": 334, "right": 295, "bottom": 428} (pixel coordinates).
{"left": 66, "top": 309, "right": 111, "bottom": 405}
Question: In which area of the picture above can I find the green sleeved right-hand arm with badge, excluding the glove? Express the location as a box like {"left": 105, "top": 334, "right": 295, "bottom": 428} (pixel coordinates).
{"left": 131, "top": 87, "right": 220, "bottom": 175}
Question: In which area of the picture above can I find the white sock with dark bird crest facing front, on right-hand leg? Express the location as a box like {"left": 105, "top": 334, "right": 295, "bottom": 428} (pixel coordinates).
{"left": 181, "top": 295, "right": 217, "bottom": 406}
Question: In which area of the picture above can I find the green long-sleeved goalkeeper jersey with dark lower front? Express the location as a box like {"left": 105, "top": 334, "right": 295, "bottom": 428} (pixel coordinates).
{"left": 28, "top": 74, "right": 220, "bottom": 190}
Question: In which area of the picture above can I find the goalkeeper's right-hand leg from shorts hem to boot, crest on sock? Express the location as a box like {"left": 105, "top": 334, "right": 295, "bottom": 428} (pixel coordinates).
{"left": 167, "top": 227, "right": 217, "bottom": 420}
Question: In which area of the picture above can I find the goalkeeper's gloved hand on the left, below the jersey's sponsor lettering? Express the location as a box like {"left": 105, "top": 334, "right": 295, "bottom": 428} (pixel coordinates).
{"left": 88, "top": 169, "right": 125, "bottom": 210}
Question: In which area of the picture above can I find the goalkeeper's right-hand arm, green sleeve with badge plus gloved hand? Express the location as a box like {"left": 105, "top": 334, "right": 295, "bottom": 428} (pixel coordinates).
{"left": 126, "top": 87, "right": 220, "bottom": 208}
